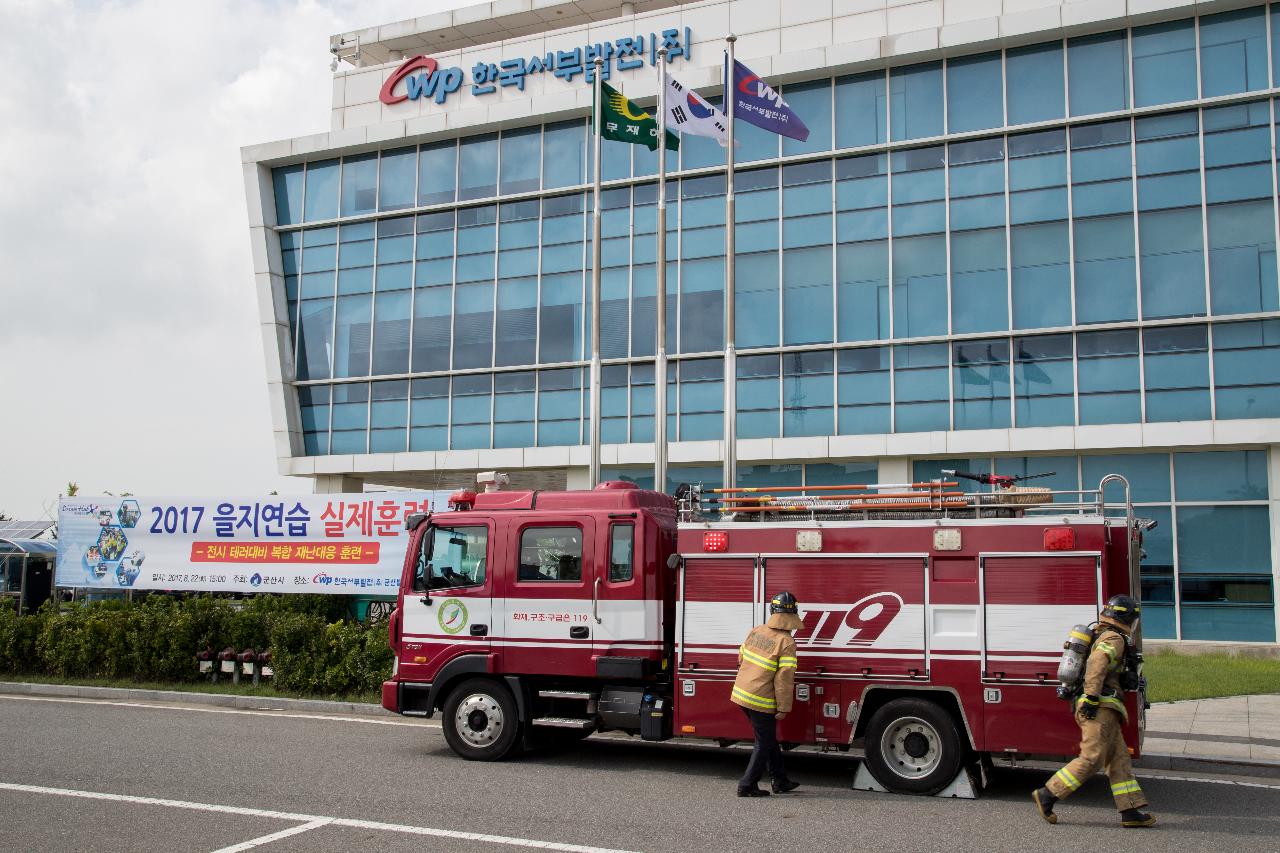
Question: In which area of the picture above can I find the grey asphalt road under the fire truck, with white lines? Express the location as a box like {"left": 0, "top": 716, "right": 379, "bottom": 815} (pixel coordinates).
{"left": 0, "top": 695, "right": 1280, "bottom": 853}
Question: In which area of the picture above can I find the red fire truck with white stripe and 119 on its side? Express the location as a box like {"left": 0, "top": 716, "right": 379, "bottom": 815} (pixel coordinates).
{"left": 383, "top": 473, "right": 1151, "bottom": 794}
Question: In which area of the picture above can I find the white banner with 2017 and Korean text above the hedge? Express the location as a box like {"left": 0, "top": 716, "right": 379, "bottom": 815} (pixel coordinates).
{"left": 55, "top": 492, "right": 451, "bottom": 596}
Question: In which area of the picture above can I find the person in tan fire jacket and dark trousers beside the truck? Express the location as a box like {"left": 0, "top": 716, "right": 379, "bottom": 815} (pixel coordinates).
{"left": 732, "top": 592, "right": 804, "bottom": 797}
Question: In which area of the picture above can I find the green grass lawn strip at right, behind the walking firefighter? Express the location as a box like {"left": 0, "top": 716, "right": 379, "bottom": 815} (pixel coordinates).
{"left": 1143, "top": 651, "right": 1280, "bottom": 702}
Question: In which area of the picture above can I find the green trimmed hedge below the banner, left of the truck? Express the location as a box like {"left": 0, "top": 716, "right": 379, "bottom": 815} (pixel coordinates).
{"left": 0, "top": 596, "right": 392, "bottom": 694}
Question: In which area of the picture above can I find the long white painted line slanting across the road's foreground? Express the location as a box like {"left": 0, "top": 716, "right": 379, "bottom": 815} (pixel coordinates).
{"left": 0, "top": 781, "right": 640, "bottom": 853}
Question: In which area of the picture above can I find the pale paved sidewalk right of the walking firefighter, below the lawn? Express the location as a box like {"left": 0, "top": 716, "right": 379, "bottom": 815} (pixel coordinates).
{"left": 1143, "top": 685, "right": 1280, "bottom": 767}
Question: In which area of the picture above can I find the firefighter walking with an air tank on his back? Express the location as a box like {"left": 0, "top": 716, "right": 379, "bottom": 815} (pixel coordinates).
{"left": 1032, "top": 596, "right": 1156, "bottom": 826}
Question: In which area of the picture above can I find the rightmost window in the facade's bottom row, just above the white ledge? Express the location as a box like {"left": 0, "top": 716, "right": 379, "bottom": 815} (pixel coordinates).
{"left": 1213, "top": 320, "right": 1280, "bottom": 418}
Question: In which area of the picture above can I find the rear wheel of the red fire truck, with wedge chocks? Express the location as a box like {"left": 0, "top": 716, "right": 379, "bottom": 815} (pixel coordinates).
{"left": 865, "top": 699, "right": 965, "bottom": 794}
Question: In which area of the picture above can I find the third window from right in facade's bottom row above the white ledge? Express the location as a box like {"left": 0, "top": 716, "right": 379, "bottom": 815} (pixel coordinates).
{"left": 1075, "top": 329, "right": 1142, "bottom": 424}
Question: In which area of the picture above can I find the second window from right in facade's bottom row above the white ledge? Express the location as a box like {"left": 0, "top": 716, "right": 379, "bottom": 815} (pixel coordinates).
{"left": 1142, "top": 325, "right": 1210, "bottom": 421}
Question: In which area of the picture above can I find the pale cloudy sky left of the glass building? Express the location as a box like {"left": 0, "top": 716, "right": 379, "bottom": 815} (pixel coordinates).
{"left": 0, "top": 0, "right": 468, "bottom": 519}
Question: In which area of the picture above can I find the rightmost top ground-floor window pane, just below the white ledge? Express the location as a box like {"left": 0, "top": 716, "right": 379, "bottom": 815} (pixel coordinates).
{"left": 1178, "top": 506, "right": 1271, "bottom": 575}
